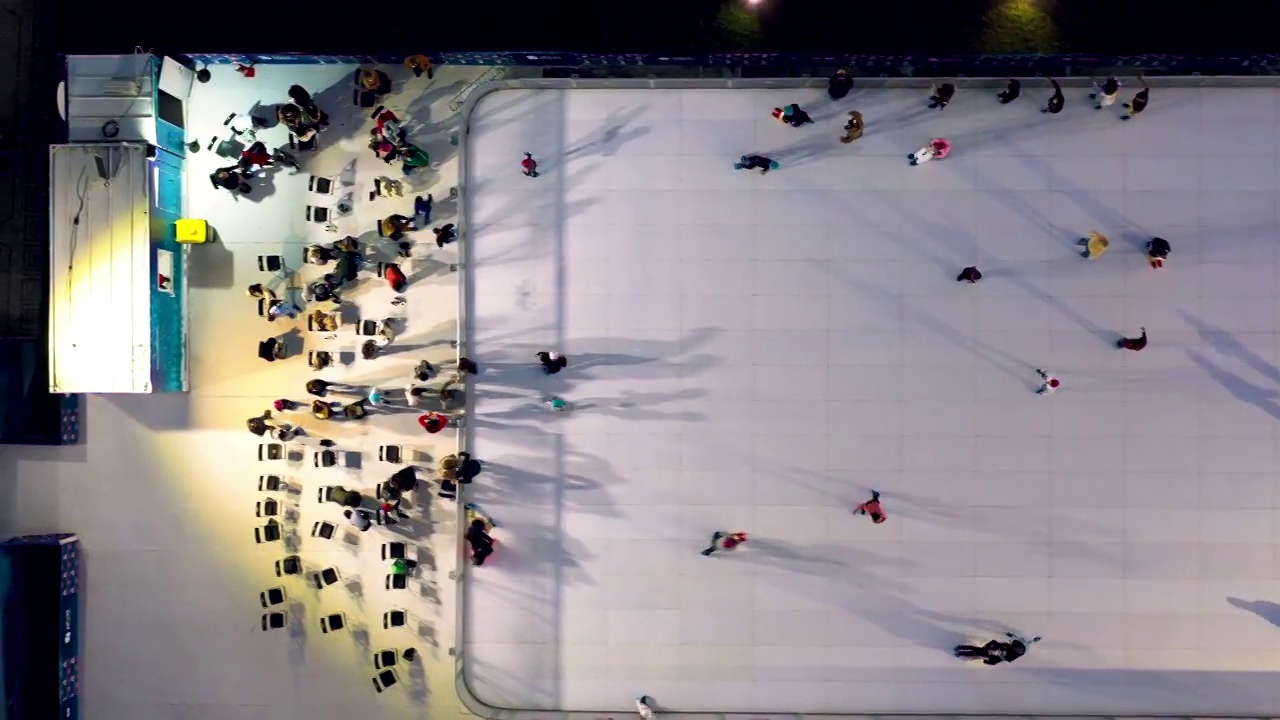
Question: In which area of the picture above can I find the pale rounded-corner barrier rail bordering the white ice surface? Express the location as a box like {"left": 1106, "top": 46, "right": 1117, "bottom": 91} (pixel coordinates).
{"left": 449, "top": 70, "right": 1280, "bottom": 720}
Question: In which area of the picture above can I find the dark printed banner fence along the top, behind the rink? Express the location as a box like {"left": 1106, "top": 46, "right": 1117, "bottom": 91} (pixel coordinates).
{"left": 186, "top": 50, "right": 1280, "bottom": 77}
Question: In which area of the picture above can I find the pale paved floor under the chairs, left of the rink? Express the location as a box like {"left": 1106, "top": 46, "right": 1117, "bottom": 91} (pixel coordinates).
{"left": 0, "top": 60, "right": 481, "bottom": 720}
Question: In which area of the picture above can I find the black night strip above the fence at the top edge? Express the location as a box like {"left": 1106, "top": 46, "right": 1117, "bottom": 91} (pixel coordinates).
{"left": 51, "top": 0, "right": 1280, "bottom": 54}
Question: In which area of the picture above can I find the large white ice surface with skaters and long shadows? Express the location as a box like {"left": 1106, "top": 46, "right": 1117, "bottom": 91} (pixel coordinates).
{"left": 462, "top": 82, "right": 1280, "bottom": 715}
